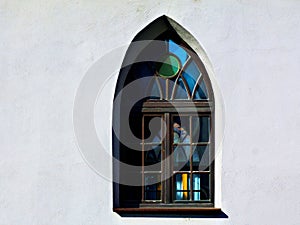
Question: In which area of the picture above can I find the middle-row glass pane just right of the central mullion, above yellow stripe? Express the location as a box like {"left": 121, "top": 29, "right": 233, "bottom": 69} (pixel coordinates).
{"left": 173, "top": 145, "right": 190, "bottom": 171}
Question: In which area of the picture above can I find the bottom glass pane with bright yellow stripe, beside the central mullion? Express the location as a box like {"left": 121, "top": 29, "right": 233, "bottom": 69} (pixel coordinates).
{"left": 175, "top": 173, "right": 190, "bottom": 200}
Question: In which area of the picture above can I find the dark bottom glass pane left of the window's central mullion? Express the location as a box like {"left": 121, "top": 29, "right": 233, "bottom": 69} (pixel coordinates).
{"left": 144, "top": 174, "right": 161, "bottom": 200}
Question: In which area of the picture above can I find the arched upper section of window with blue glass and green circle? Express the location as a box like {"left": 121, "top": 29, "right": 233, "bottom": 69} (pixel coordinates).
{"left": 147, "top": 39, "right": 208, "bottom": 101}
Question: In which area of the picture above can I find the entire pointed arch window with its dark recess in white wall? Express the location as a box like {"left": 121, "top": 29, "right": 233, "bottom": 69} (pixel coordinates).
{"left": 113, "top": 16, "right": 219, "bottom": 214}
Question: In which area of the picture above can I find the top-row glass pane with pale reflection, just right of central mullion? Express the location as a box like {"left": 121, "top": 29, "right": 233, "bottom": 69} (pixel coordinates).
{"left": 172, "top": 116, "right": 191, "bottom": 144}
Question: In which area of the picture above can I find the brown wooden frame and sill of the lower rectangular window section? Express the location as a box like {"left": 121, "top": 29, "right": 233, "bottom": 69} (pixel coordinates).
{"left": 113, "top": 100, "right": 221, "bottom": 215}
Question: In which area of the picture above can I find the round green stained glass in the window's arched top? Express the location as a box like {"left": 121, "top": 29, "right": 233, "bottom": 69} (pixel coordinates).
{"left": 157, "top": 55, "right": 180, "bottom": 78}
